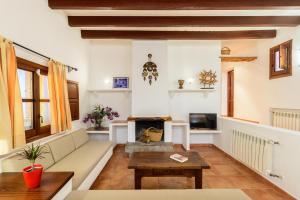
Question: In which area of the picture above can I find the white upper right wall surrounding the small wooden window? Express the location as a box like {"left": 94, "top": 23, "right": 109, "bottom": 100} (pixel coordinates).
{"left": 222, "top": 26, "right": 300, "bottom": 124}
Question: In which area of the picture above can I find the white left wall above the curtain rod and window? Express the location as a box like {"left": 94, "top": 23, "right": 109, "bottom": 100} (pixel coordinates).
{"left": 0, "top": 0, "right": 88, "bottom": 128}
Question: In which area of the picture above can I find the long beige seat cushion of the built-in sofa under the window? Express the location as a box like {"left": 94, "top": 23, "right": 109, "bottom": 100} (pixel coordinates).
{"left": 47, "top": 140, "right": 112, "bottom": 189}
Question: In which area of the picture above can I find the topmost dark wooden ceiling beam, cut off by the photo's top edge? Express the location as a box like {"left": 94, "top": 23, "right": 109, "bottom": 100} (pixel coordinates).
{"left": 48, "top": 0, "right": 300, "bottom": 10}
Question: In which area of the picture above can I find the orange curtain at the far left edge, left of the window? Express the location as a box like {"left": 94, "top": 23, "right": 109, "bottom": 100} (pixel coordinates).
{"left": 0, "top": 36, "right": 26, "bottom": 154}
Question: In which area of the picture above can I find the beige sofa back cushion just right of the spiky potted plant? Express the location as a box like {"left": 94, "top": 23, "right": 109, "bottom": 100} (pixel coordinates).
{"left": 48, "top": 135, "right": 75, "bottom": 162}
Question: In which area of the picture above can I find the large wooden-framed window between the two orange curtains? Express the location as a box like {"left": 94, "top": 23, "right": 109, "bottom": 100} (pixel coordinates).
{"left": 17, "top": 58, "right": 50, "bottom": 142}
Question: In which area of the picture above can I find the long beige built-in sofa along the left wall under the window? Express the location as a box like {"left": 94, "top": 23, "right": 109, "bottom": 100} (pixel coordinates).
{"left": 1, "top": 129, "right": 113, "bottom": 190}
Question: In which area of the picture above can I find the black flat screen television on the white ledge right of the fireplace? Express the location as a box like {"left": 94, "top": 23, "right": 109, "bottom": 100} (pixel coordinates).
{"left": 190, "top": 113, "right": 217, "bottom": 130}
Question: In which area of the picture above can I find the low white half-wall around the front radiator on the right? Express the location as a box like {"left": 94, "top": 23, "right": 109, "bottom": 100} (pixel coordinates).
{"left": 214, "top": 118, "right": 300, "bottom": 199}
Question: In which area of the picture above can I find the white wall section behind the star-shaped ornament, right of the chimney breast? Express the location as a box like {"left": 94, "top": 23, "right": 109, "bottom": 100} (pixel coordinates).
{"left": 168, "top": 41, "right": 221, "bottom": 121}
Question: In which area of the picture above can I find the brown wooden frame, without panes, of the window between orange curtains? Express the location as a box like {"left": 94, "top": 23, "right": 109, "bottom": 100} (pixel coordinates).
{"left": 17, "top": 57, "right": 51, "bottom": 143}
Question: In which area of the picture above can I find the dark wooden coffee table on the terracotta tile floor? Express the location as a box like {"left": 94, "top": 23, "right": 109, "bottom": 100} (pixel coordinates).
{"left": 128, "top": 152, "right": 210, "bottom": 189}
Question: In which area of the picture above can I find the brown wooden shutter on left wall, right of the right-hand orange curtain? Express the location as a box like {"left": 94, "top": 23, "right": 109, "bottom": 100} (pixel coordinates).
{"left": 67, "top": 80, "right": 79, "bottom": 121}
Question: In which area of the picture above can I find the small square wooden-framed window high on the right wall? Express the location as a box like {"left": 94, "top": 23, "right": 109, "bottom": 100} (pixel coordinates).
{"left": 270, "top": 40, "right": 292, "bottom": 79}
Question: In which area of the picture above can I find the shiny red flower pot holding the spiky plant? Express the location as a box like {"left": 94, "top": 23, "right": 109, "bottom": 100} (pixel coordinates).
{"left": 23, "top": 164, "right": 43, "bottom": 189}
